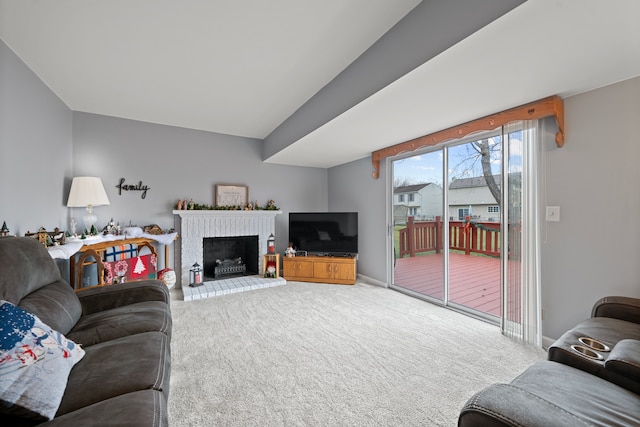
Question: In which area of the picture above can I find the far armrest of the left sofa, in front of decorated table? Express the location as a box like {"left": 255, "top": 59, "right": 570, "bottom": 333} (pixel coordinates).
{"left": 76, "top": 280, "right": 171, "bottom": 315}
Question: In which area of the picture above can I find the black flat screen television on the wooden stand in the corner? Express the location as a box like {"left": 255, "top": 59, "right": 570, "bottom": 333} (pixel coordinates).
{"left": 289, "top": 212, "right": 358, "bottom": 256}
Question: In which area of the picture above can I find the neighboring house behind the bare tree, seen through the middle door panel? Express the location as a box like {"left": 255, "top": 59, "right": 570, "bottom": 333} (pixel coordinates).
{"left": 449, "top": 173, "right": 521, "bottom": 221}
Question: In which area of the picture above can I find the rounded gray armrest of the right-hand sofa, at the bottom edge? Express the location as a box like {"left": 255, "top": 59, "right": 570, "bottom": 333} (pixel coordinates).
{"left": 458, "top": 384, "right": 587, "bottom": 427}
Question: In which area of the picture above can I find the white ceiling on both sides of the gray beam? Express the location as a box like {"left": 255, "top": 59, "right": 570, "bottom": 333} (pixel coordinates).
{"left": 0, "top": 0, "right": 640, "bottom": 167}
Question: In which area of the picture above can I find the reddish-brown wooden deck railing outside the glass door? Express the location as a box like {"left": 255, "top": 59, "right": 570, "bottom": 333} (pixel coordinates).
{"left": 398, "top": 216, "right": 500, "bottom": 258}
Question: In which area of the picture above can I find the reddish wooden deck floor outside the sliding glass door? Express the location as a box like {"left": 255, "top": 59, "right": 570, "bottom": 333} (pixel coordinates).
{"left": 394, "top": 253, "right": 500, "bottom": 317}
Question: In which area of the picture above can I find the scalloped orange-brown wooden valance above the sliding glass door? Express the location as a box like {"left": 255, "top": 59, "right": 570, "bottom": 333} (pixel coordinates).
{"left": 371, "top": 96, "right": 564, "bottom": 179}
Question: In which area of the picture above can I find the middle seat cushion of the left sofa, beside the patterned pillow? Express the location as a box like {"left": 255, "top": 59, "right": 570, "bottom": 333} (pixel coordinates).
{"left": 58, "top": 332, "right": 171, "bottom": 415}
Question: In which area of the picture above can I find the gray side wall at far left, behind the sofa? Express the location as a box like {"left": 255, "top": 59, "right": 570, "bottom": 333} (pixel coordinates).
{"left": 0, "top": 41, "right": 72, "bottom": 235}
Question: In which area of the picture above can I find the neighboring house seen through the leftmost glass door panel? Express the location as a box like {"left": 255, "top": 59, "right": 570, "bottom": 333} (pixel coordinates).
{"left": 393, "top": 183, "right": 442, "bottom": 224}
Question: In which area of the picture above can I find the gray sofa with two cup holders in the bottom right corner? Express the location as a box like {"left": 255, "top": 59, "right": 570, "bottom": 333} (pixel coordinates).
{"left": 458, "top": 297, "right": 640, "bottom": 427}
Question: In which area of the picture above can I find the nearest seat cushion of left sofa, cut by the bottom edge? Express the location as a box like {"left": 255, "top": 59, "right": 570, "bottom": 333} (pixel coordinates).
{"left": 40, "top": 390, "right": 169, "bottom": 427}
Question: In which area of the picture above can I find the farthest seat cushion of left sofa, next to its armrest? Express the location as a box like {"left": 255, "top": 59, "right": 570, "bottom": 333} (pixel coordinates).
{"left": 67, "top": 301, "right": 171, "bottom": 346}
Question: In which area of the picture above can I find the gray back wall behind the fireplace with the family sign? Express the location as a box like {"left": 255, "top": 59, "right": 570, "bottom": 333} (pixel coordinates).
{"left": 70, "top": 112, "right": 327, "bottom": 251}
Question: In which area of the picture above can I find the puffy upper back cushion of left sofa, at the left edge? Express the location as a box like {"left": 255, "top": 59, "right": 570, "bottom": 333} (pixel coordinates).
{"left": 0, "top": 237, "right": 61, "bottom": 305}
